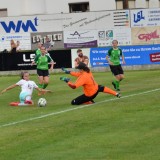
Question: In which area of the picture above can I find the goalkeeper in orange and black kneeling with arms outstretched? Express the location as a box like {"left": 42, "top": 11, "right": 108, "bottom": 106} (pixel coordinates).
{"left": 60, "top": 62, "right": 120, "bottom": 105}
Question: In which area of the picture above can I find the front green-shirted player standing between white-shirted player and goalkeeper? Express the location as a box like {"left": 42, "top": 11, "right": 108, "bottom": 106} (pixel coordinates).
{"left": 32, "top": 46, "right": 54, "bottom": 95}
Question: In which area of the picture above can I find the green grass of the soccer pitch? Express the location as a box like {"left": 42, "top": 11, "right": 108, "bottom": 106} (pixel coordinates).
{"left": 0, "top": 70, "right": 160, "bottom": 160}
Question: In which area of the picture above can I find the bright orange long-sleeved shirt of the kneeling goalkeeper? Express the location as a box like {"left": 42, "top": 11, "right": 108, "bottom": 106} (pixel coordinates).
{"left": 68, "top": 72, "right": 98, "bottom": 97}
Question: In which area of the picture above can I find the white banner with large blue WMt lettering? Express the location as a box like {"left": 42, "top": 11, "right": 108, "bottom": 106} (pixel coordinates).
{"left": 0, "top": 14, "right": 62, "bottom": 34}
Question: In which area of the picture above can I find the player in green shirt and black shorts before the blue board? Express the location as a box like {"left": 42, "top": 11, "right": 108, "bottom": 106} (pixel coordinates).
{"left": 106, "top": 40, "right": 126, "bottom": 91}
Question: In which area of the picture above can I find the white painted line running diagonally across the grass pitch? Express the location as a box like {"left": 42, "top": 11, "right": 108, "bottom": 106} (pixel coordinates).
{"left": 0, "top": 88, "right": 160, "bottom": 128}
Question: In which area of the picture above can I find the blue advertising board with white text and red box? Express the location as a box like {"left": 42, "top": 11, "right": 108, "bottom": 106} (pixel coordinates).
{"left": 90, "top": 44, "right": 160, "bottom": 67}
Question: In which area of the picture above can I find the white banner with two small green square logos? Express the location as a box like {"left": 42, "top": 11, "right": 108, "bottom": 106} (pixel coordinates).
{"left": 98, "top": 28, "right": 131, "bottom": 47}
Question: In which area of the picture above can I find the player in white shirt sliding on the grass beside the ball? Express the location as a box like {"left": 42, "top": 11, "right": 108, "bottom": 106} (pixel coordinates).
{"left": 1, "top": 72, "right": 51, "bottom": 106}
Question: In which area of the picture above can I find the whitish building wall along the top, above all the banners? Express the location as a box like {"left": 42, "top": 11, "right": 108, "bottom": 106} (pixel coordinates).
{"left": 0, "top": 0, "right": 160, "bottom": 16}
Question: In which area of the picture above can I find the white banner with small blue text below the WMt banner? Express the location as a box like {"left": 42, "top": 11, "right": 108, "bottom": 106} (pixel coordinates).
{"left": 0, "top": 33, "right": 31, "bottom": 51}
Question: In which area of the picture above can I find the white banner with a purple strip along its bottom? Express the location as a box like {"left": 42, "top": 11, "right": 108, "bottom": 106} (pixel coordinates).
{"left": 64, "top": 30, "right": 97, "bottom": 48}
